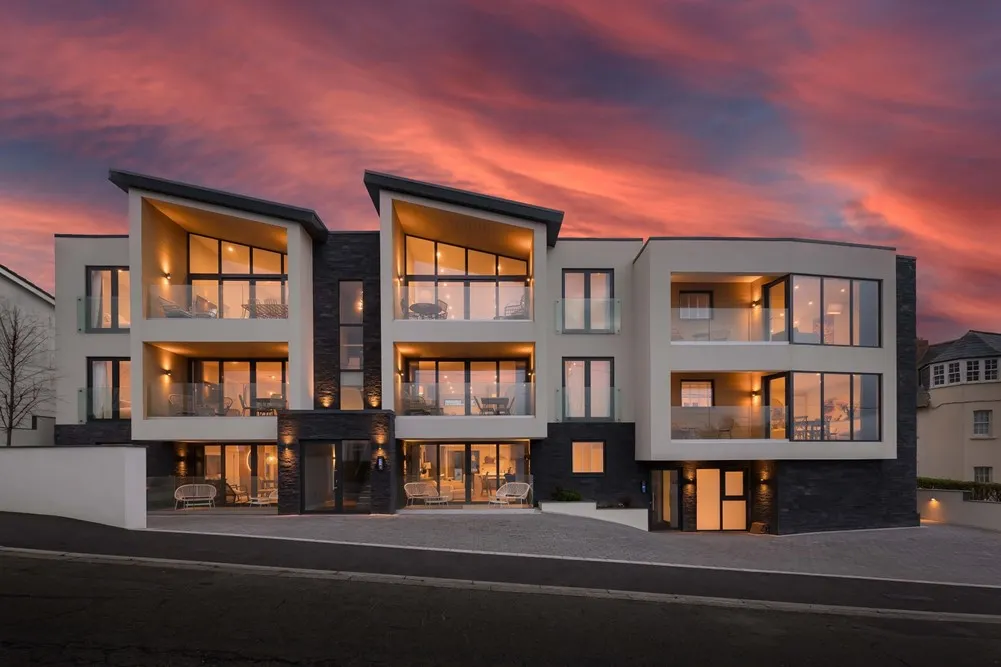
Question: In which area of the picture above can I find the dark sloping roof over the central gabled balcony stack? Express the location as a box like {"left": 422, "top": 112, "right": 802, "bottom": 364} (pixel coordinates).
{"left": 364, "top": 169, "right": 564, "bottom": 246}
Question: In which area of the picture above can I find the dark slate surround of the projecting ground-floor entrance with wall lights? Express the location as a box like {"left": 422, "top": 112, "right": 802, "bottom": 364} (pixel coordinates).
{"left": 278, "top": 410, "right": 399, "bottom": 514}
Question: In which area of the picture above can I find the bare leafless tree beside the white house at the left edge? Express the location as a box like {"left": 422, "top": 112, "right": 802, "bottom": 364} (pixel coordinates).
{"left": 0, "top": 300, "right": 55, "bottom": 447}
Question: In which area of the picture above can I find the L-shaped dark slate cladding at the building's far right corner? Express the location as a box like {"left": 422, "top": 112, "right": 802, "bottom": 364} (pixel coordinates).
{"left": 777, "top": 256, "right": 919, "bottom": 534}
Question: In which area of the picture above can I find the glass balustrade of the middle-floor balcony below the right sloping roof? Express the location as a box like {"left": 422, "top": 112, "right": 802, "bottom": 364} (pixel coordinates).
{"left": 399, "top": 383, "right": 536, "bottom": 418}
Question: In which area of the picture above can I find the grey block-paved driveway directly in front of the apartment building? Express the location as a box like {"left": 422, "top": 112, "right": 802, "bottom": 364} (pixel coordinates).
{"left": 148, "top": 512, "right": 1001, "bottom": 586}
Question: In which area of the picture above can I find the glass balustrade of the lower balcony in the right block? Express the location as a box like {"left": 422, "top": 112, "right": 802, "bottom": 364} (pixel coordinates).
{"left": 671, "top": 406, "right": 787, "bottom": 440}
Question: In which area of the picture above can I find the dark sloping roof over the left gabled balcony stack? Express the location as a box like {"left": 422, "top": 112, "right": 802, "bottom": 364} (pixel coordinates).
{"left": 108, "top": 169, "right": 327, "bottom": 242}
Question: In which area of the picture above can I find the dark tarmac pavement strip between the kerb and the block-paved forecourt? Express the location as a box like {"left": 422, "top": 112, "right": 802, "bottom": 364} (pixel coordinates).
{"left": 0, "top": 514, "right": 1001, "bottom": 620}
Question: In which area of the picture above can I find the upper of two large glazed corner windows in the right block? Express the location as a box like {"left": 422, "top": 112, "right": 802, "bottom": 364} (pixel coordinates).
{"left": 791, "top": 275, "right": 880, "bottom": 348}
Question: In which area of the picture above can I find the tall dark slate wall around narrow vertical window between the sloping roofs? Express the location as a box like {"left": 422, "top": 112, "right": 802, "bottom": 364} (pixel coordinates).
{"left": 312, "top": 231, "right": 382, "bottom": 409}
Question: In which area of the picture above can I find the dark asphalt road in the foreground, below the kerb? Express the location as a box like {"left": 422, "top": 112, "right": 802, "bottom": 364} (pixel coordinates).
{"left": 0, "top": 552, "right": 1001, "bottom": 667}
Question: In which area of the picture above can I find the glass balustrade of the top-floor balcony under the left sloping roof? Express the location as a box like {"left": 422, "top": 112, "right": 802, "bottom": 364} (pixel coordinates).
{"left": 146, "top": 280, "right": 288, "bottom": 319}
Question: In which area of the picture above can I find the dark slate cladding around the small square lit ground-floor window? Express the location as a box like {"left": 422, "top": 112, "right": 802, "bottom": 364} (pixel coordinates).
{"left": 531, "top": 422, "right": 650, "bottom": 508}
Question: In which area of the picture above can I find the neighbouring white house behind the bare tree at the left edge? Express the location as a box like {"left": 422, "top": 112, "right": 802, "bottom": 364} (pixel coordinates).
{"left": 0, "top": 264, "right": 56, "bottom": 446}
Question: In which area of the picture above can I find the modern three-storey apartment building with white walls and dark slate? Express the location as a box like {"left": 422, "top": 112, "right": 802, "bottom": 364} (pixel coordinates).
{"left": 56, "top": 171, "right": 918, "bottom": 533}
